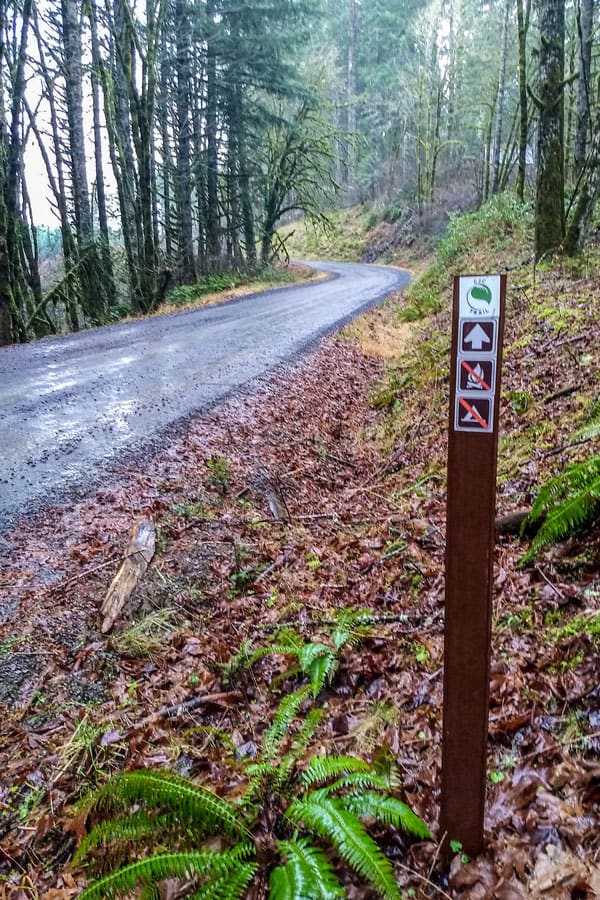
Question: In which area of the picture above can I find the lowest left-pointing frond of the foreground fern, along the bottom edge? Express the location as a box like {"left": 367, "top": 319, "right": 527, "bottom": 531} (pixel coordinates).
{"left": 80, "top": 850, "right": 238, "bottom": 900}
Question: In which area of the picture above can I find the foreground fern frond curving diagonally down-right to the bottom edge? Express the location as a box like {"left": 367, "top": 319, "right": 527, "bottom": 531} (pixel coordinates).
{"left": 285, "top": 796, "right": 400, "bottom": 900}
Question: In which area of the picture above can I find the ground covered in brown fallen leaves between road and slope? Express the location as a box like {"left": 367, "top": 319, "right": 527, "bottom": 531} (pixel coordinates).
{"left": 0, "top": 220, "right": 600, "bottom": 900}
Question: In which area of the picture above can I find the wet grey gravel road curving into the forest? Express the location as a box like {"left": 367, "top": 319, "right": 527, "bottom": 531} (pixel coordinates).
{"left": 0, "top": 263, "right": 409, "bottom": 527}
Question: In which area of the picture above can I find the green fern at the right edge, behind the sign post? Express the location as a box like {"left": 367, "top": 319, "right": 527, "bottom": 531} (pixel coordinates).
{"left": 521, "top": 455, "right": 600, "bottom": 564}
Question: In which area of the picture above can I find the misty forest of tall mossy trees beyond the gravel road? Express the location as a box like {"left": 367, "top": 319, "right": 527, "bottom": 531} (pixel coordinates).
{"left": 0, "top": 0, "right": 600, "bottom": 344}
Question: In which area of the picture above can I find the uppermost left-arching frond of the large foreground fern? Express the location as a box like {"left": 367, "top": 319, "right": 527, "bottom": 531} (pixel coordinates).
{"left": 83, "top": 769, "right": 246, "bottom": 837}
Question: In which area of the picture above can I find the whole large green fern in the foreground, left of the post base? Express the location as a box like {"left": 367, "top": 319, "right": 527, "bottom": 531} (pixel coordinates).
{"left": 75, "top": 690, "right": 431, "bottom": 900}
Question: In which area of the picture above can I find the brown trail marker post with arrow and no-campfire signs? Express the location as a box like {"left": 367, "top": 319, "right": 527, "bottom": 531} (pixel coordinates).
{"left": 441, "top": 275, "right": 506, "bottom": 856}
